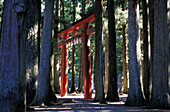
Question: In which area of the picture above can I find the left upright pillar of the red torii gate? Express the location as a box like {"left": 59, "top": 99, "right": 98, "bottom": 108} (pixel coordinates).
{"left": 61, "top": 34, "right": 68, "bottom": 97}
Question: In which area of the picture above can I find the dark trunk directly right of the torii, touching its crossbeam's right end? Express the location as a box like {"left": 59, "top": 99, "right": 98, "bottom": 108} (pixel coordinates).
{"left": 94, "top": 0, "right": 105, "bottom": 103}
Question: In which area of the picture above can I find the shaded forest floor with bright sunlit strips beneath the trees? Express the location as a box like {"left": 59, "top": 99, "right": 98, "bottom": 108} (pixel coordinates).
{"left": 28, "top": 93, "right": 169, "bottom": 112}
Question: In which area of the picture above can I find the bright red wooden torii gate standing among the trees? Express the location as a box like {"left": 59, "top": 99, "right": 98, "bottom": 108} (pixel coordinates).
{"left": 58, "top": 12, "right": 95, "bottom": 99}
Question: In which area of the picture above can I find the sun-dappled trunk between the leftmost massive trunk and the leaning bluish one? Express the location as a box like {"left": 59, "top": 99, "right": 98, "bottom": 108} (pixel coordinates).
{"left": 26, "top": 0, "right": 41, "bottom": 104}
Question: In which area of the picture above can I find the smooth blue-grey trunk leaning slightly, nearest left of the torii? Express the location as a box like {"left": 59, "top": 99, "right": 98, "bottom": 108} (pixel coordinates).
{"left": 32, "top": 0, "right": 56, "bottom": 105}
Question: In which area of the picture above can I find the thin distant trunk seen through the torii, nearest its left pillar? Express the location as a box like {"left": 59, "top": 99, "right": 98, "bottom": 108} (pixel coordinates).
{"left": 71, "top": 0, "right": 76, "bottom": 93}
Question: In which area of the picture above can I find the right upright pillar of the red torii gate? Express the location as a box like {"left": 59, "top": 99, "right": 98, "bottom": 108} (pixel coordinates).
{"left": 83, "top": 23, "right": 92, "bottom": 99}
